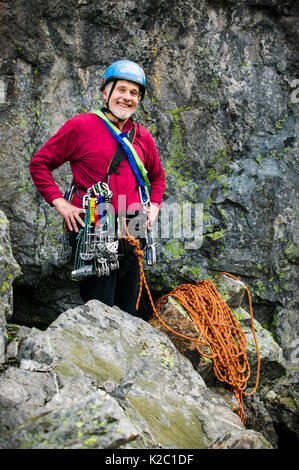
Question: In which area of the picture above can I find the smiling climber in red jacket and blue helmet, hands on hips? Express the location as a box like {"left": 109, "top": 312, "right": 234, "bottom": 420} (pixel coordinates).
{"left": 30, "top": 60, "right": 165, "bottom": 314}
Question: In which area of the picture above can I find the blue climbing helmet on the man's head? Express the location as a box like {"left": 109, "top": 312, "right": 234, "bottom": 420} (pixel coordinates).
{"left": 101, "top": 60, "right": 146, "bottom": 100}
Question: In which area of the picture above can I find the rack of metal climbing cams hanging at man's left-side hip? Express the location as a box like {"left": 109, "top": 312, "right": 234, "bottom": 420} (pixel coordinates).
{"left": 72, "top": 183, "right": 119, "bottom": 280}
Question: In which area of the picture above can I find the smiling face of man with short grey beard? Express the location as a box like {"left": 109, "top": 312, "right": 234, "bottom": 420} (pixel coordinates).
{"left": 103, "top": 80, "right": 139, "bottom": 119}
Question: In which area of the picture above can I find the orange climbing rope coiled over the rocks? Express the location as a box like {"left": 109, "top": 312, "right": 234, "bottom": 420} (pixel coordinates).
{"left": 125, "top": 232, "right": 260, "bottom": 424}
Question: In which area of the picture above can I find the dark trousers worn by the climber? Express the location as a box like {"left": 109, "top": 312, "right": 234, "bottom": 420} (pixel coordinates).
{"left": 80, "top": 240, "right": 140, "bottom": 315}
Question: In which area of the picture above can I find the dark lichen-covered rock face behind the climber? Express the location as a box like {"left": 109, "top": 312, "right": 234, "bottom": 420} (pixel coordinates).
{"left": 0, "top": 0, "right": 298, "bottom": 361}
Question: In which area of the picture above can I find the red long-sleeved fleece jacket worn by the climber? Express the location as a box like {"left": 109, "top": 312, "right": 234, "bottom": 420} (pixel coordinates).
{"left": 30, "top": 113, "right": 165, "bottom": 213}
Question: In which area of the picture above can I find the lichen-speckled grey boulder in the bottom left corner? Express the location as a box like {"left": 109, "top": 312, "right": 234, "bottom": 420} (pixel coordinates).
{"left": 0, "top": 390, "right": 138, "bottom": 449}
